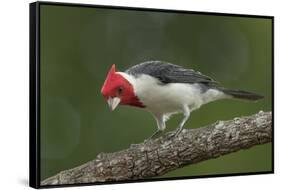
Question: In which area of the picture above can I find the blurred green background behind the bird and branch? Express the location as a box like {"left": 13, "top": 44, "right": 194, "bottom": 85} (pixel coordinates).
{"left": 40, "top": 5, "right": 272, "bottom": 179}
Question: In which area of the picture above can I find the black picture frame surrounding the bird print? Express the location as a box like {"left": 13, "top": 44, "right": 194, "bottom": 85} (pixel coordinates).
{"left": 29, "top": 1, "right": 274, "bottom": 188}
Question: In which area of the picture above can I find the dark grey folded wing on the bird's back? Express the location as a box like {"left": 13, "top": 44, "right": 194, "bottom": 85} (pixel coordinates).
{"left": 125, "top": 61, "right": 217, "bottom": 84}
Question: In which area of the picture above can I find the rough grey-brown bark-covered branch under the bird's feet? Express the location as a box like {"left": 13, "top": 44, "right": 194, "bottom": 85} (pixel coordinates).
{"left": 41, "top": 111, "right": 272, "bottom": 185}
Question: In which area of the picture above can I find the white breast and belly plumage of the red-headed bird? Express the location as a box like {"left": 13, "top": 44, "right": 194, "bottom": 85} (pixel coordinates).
{"left": 117, "top": 72, "right": 224, "bottom": 115}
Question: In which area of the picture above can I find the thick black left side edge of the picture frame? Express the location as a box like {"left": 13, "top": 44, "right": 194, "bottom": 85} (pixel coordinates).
{"left": 29, "top": 2, "right": 40, "bottom": 188}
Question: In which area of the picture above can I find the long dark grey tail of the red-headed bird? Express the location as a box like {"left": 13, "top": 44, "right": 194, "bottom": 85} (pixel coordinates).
{"left": 217, "top": 87, "right": 264, "bottom": 101}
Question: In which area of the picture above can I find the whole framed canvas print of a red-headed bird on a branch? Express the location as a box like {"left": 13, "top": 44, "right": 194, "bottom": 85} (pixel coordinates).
{"left": 30, "top": 2, "right": 274, "bottom": 188}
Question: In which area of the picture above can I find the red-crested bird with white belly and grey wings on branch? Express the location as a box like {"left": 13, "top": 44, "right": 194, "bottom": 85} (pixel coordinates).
{"left": 101, "top": 60, "right": 263, "bottom": 139}
